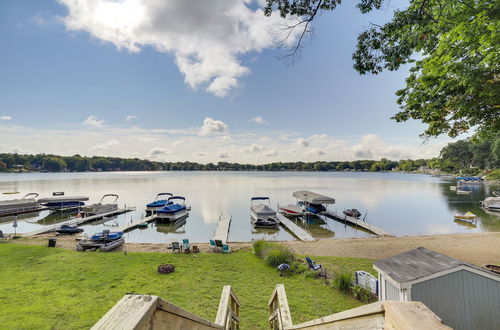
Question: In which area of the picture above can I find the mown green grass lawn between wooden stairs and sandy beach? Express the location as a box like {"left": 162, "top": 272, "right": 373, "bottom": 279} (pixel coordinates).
{"left": 0, "top": 244, "right": 372, "bottom": 329}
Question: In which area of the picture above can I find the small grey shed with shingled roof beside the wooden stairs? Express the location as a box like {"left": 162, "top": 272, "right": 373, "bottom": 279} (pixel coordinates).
{"left": 373, "top": 247, "right": 500, "bottom": 330}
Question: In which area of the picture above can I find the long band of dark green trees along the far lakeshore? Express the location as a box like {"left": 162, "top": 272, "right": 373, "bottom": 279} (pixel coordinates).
{"left": 0, "top": 136, "right": 500, "bottom": 175}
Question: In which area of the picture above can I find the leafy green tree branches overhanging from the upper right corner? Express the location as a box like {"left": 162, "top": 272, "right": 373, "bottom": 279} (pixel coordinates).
{"left": 265, "top": 0, "right": 500, "bottom": 137}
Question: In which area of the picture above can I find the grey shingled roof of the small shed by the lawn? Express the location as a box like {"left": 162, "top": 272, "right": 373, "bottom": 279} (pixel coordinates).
{"left": 374, "top": 247, "right": 496, "bottom": 283}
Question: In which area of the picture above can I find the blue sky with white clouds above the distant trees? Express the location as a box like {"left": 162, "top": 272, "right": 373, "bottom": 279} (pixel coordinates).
{"left": 0, "top": 0, "right": 456, "bottom": 164}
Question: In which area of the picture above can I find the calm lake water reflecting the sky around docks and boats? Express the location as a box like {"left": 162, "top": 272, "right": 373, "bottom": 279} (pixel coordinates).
{"left": 0, "top": 172, "right": 500, "bottom": 243}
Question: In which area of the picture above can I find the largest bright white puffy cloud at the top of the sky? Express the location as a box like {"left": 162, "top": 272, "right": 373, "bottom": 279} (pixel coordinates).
{"left": 58, "top": 0, "right": 296, "bottom": 97}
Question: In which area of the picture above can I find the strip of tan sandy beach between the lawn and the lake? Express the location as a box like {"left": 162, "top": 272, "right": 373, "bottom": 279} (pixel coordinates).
{"left": 5, "top": 232, "right": 500, "bottom": 266}
